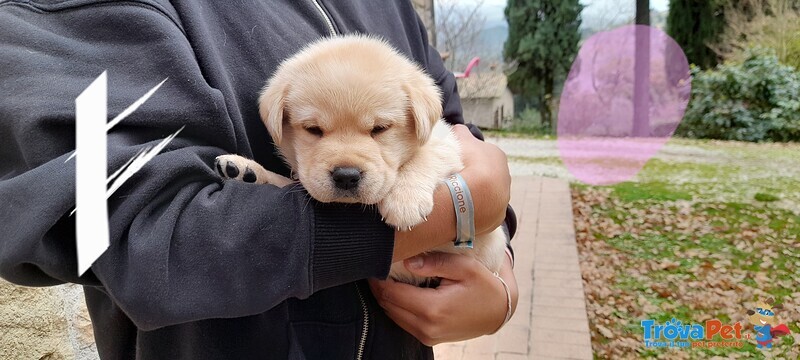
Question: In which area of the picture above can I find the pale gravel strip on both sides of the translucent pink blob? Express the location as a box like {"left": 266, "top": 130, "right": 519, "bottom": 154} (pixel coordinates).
{"left": 487, "top": 135, "right": 800, "bottom": 212}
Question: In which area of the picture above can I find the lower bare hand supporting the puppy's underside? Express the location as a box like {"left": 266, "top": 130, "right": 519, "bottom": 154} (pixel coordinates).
{"left": 369, "top": 253, "right": 519, "bottom": 346}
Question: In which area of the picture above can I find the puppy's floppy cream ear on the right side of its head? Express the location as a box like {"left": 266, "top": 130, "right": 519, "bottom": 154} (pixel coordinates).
{"left": 403, "top": 70, "right": 442, "bottom": 145}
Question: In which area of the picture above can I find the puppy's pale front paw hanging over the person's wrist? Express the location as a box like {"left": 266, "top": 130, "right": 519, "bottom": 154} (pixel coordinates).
{"left": 378, "top": 187, "right": 433, "bottom": 231}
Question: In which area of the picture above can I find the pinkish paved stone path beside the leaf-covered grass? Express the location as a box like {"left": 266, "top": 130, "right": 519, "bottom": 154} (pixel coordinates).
{"left": 434, "top": 176, "right": 592, "bottom": 360}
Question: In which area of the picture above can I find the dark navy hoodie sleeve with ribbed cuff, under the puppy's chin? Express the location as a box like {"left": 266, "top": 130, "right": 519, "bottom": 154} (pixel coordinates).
{"left": 0, "top": 2, "right": 394, "bottom": 330}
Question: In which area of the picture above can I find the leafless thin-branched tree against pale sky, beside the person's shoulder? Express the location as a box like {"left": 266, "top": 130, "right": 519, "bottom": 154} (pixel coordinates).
{"left": 436, "top": 0, "right": 486, "bottom": 71}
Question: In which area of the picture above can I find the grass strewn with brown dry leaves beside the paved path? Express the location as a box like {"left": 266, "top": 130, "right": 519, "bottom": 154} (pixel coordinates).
{"left": 573, "top": 187, "right": 800, "bottom": 359}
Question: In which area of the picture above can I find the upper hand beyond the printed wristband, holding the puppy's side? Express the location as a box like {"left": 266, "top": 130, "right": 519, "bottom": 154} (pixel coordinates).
{"left": 453, "top": 125, "right": 511, "bottom": 235}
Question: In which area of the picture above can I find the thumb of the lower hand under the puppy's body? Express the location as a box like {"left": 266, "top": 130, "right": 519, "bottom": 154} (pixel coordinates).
{"left": 403, "top": 252, "right": 483, "bottom": 280}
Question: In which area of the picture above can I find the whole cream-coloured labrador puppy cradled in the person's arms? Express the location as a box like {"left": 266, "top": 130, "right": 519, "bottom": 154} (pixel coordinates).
{"left": 216, "top": 35, "right": 506, "bottom": 284}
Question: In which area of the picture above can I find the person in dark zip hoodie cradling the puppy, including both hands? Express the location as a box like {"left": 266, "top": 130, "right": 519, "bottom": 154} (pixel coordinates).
{"left": 0, "top": 0, "right": 516, "bottom": 359}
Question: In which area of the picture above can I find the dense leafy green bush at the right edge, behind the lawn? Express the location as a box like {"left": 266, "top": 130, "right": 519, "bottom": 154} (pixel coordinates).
{"left": 676, "top": 49, "right": 800, "bottom": 142}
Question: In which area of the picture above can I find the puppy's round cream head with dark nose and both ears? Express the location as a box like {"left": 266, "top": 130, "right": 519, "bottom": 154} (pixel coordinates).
{"left": 259, "top": 36, "right": 442, "bottom": 204}
